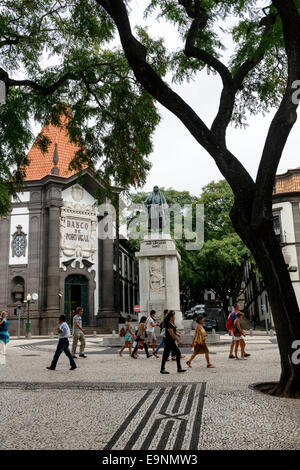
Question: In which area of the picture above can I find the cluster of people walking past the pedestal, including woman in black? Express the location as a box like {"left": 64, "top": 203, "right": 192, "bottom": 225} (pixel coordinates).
{"left": 119, "top": 310, "right": 214, "bottom": 374}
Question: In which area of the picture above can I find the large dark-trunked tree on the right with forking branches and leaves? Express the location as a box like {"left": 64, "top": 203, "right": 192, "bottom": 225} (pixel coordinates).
{"left": 97, "top": 0, "right": 300, "bottom": 397}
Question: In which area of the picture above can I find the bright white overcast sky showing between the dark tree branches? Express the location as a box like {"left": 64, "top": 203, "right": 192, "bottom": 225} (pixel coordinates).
{"left": 125, "top": 0, "right": 300, "bottom": 195}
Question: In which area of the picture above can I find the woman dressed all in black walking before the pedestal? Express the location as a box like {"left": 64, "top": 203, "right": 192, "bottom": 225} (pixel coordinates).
{"left": 160, "top": 310, "right": 186, "bottom": 374}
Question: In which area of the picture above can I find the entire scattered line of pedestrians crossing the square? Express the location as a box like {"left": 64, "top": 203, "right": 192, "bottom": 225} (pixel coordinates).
{"left": 0, "top": 304, "right": 250, "bottom": 374}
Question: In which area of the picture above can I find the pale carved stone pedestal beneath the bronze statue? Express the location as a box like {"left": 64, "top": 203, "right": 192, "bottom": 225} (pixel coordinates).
{"left": 136, "top": 233, "right": 183, "bottom": 330}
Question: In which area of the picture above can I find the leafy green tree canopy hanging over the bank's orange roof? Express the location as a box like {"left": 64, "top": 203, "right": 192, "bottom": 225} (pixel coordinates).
{"left": 0, "top": 0, "right": 164, "bottom": 215}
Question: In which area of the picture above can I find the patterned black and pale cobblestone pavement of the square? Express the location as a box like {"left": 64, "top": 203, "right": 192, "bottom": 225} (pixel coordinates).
{"left": 0, "top": 335, "right": 300, "bottom": 450}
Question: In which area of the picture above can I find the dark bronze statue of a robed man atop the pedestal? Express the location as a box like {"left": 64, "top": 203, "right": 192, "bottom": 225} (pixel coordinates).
{"left": 144, "top": 186, "right": 168, "bottom": 232}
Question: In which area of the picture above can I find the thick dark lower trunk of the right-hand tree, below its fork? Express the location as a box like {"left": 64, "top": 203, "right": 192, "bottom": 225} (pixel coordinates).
{"left": 230, "top": 201, "right": 300, "bottom": 398}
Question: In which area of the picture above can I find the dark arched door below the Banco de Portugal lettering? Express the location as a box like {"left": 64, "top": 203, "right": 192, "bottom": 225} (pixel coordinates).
{"left": 65, "top": 274, "right": 89, "bottom": 326}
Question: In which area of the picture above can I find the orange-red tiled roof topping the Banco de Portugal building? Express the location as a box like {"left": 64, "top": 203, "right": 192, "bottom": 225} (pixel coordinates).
{"left": 25, "top": 115, "right": 79, "bottom": 181}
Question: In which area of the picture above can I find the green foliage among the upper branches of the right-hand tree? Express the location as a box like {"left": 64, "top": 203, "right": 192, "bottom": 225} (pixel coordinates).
{"left": 146, "top": 0, "right": 300, "bottom": 127}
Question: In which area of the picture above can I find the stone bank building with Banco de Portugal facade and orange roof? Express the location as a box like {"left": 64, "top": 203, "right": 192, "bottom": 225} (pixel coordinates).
{"left": 0, "top": 119, "right": 138, "bottom": 335}
